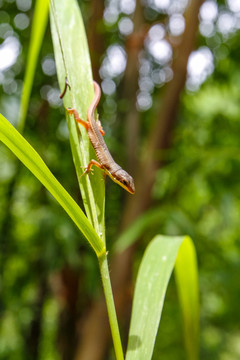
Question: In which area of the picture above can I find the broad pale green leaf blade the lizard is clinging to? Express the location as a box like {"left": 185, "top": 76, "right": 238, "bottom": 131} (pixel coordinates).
{"left": 50, "top": 0, "right": 105, "bottom": 241}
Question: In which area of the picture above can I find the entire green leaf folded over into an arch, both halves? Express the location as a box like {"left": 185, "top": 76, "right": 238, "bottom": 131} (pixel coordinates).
{"left": 126, "top": 236, "right": 199, "bottom": 360}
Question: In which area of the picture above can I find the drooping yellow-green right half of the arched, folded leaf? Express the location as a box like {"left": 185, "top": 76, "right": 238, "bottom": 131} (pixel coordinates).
{"left": 175, "top": 237, "right": 199, "bottom": 360}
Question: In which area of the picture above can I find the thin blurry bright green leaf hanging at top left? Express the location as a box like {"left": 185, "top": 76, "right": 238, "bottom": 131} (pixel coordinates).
{"left": 17, "top": 0, "right": 49, "bottom": 132}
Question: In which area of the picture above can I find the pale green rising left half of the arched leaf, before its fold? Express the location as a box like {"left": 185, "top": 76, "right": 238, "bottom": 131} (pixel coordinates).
{"left": 126, "top": 236, "right": 199, "bottom": 360}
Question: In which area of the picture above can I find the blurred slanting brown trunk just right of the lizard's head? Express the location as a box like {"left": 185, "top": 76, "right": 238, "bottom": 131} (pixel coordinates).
{"left": 127, "top": 0, "right": 203, "bottom": 217}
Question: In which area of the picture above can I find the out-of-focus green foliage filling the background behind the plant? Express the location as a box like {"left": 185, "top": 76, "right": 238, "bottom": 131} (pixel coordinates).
{"left": 0, "top": 0, "right": 240, "bottom": 360}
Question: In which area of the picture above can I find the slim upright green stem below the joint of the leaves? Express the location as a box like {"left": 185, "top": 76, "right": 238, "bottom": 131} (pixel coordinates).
{"left": 98, "top": 253, "right": 124, "bottom": 360}
